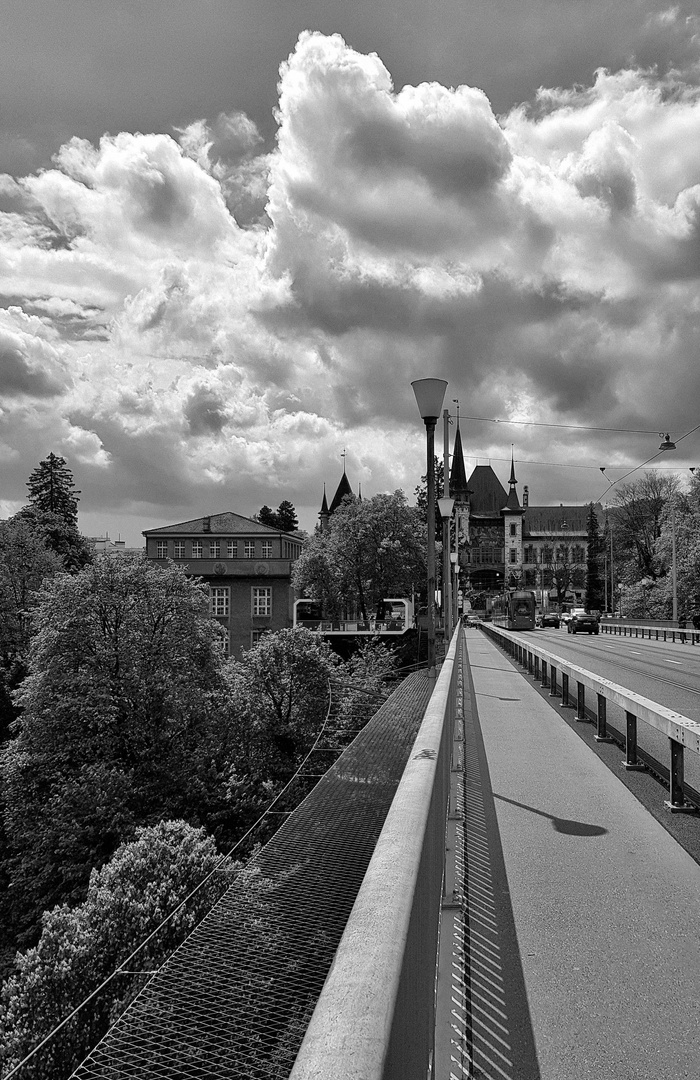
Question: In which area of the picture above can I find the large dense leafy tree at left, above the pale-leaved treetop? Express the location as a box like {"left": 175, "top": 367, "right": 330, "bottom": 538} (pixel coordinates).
{"left": 0, "top": 554, "right": 230, "bottom": 935}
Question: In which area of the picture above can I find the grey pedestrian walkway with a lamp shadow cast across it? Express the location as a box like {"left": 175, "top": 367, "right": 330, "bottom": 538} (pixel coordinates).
{"left": 465, "top": 629, "right": 700, "bottom": 1080}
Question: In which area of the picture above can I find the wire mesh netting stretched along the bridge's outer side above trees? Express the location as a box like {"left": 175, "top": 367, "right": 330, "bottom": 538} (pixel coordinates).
{"left": 72, "top": 672, "right": 432, "bottom": 1080}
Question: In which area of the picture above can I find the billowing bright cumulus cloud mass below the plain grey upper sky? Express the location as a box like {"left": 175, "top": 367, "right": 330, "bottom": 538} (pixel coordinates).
{"left": 0, "top": 32, "right": 700, "bottom": 540}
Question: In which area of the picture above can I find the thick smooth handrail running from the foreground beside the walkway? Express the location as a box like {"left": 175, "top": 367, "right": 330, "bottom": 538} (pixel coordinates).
{"left": 290, "top": 627, "right": 462, "bottom": 1080}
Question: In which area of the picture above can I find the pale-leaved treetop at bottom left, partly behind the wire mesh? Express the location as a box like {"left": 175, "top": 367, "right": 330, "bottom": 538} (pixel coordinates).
{"left": 0, "top": 821, "right": 229, "bottom": 1080}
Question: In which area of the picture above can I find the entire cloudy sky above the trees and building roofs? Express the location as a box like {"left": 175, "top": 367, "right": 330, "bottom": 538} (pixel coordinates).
{"left": 0, "top": 0, "right": 700, "bottom": 545}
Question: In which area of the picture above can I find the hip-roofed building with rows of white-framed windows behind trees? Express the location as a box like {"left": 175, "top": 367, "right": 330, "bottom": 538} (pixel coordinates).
{"left": 144, "top": 512, "right": 302, "bottom": 656}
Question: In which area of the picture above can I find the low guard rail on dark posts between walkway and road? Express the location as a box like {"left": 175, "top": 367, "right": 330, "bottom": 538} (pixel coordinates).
{"left": 481, "top": 623, "right": 700, "bottom": 812}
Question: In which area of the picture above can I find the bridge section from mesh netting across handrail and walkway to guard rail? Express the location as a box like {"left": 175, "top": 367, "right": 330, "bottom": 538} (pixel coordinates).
{"left": 47, "top": 627, "right": 700, "bottom": 1080}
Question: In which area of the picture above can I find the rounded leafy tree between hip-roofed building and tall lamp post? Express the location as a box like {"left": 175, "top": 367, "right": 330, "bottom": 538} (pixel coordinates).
{"left": 292, "top": 490, "right": 427, "bottom": 619}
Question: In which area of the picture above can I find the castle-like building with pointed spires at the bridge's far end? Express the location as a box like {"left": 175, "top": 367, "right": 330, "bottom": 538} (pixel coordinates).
{"left": 449, "top": 431, "right": 602, "bottom": 609}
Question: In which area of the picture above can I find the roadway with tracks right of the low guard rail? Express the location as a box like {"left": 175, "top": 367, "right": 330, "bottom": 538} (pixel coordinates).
{"left": 505, "top": 629, "right": 700, "bottom": 791}
